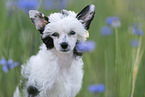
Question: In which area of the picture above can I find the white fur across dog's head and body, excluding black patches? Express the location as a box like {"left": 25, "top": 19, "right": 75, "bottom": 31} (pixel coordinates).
{"left": 14, "top": 5, "right": 94, "bottom": 97}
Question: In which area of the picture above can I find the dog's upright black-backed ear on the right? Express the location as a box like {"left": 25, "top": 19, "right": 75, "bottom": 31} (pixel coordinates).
{"left": 76, "top": 5, "right": 95, "bottom": 30}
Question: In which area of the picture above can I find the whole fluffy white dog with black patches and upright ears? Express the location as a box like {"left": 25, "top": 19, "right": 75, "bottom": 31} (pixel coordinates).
{"left": 14, "top": 5, "right": 95, "bottom": 97}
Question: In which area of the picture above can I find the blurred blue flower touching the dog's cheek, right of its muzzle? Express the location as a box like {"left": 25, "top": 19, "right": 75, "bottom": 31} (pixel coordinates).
{"left": 76, "top": 41, "right": 96, "bottom": 52}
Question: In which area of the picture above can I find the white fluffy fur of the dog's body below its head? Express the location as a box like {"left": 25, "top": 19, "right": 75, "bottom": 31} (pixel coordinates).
{"left": 22, "top": 45, "right": 83, "bottom": 97}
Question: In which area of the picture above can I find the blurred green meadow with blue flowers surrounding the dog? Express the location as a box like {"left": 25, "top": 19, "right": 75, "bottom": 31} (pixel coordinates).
{"left": 0, "top": 0, "right": 145, "bottom": 97}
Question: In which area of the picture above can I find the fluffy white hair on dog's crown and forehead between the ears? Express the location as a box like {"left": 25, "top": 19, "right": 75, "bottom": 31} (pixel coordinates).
{"left": 43, "top": 10, "right": 88, "bottom": 40}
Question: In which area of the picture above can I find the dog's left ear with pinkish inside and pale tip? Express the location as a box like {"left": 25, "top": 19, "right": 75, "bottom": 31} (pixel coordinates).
{"left": 29, "top": 10, "right": 49, "bottom": 34}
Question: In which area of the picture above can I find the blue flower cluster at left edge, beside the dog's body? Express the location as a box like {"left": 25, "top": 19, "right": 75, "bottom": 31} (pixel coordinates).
{"left": 0, "top": 58, "right": 19, "bottom": 73}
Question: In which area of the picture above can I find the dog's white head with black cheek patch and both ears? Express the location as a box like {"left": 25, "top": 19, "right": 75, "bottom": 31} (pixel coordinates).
{"left": 29, "top": 5, "right": 95, "bottom": 52}
